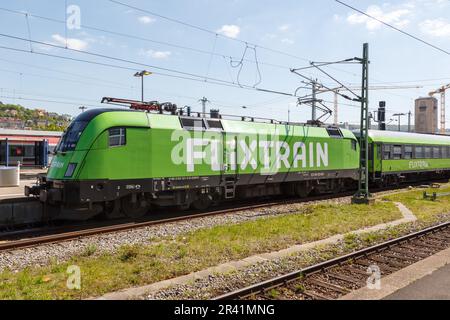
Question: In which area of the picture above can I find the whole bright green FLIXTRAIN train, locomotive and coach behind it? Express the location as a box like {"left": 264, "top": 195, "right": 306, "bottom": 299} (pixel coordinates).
{"left": 25, "top": 98, "right": 450, "bottom": 219}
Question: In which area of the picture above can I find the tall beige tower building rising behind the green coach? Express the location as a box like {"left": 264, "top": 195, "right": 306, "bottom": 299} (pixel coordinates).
{"left": 415, "top": 97, "right": 438, "bottom": 134}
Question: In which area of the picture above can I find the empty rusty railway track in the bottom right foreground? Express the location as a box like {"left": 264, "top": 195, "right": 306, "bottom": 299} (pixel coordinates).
{"left": 215, "top": 222, "right": 450, "bottom": 300}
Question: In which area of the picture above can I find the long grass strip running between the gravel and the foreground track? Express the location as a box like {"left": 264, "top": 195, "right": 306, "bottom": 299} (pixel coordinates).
{"left": 0, "top": 202, "right": 401, "bottom": 299}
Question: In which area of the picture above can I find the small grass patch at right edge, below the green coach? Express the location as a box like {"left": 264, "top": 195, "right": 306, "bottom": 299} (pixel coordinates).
{"left": 383, "top": 185, "right": 450, "bottom": 221}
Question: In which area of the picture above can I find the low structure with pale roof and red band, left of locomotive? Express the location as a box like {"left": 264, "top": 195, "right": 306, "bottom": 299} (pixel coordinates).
{"left": 0, "top": 129, "right": 62, "bottom": 167}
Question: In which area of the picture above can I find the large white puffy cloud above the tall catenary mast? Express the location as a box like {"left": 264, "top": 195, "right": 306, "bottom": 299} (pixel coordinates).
{"left": 347, "top": 5, "right": 412, "bottom": 31}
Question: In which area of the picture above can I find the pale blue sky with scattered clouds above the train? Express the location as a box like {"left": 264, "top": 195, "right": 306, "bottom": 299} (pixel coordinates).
{"left": 0, "top": 0, "right": 450, "bottom": 127}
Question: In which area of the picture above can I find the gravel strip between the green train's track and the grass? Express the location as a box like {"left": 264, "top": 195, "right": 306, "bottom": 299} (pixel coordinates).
{"left": 0, "top": 197, "right": 351, "bottom": 272}
